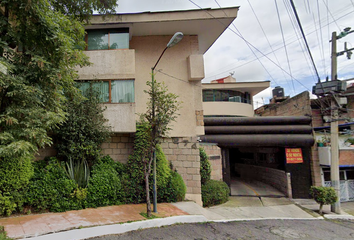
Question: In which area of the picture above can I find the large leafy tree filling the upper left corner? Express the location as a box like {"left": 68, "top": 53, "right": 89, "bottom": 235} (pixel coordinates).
{"left": 0, "top": 0, "right": 116, "bottom": 159}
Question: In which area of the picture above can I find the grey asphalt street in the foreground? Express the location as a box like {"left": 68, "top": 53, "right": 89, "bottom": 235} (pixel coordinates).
{"left": 90, "top": 220, "right": 354, "bottom": 240}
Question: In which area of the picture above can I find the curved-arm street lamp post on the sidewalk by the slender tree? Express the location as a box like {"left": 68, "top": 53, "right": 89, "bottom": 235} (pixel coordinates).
{"left": 151, "top": 32, "right": 183, "bottom": 213}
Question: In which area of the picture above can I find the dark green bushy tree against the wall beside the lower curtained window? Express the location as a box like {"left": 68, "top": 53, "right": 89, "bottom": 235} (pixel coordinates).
{"left": 55, "top": 85, "right": 111, "bottom": 166}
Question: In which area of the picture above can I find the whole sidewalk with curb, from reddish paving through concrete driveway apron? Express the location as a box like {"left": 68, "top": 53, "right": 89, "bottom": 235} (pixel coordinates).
{"left": 0, "top": 197, "right": 354, "bottom": 240}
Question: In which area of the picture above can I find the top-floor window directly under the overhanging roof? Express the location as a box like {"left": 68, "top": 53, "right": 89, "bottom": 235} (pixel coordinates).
{"left": 85, "top": 28, "right": 129, "bottom": 50}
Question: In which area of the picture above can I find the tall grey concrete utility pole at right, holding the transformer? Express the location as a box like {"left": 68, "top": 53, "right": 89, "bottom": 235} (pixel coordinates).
{"left": 331, "top": 32, "right": 341, "bottom": 213}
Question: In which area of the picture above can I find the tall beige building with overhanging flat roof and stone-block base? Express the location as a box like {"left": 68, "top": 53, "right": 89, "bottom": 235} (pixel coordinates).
{"left": 40, "top": 7, "right": 238, "bottom": 204}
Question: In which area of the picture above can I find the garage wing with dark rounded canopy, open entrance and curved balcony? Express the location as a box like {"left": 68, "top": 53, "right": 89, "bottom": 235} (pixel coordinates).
{"left": 201, "top": 83, "right": 314, "bottom": 198}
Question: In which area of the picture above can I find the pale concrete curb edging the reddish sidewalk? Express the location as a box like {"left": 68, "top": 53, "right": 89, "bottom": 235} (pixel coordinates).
{"left": 18, "top": 215, "right": 208, "bottom": 240}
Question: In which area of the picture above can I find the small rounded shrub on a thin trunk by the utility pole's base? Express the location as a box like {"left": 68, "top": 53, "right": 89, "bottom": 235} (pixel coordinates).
{"left": 310, "top": 186, "right": 338, "bottom": 214}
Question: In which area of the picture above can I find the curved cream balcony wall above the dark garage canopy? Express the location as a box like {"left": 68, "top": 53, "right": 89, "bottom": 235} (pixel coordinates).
{"left": 203, "top": 102, "right": 254, "bottom": 117}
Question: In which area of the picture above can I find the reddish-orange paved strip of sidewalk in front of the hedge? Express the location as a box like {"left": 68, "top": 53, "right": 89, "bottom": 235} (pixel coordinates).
{"left": 0, "top": 203, "right": 188, "bottom": 239}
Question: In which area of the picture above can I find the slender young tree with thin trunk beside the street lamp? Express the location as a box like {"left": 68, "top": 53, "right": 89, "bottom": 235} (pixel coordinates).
{"left": 140, "top": 76, "right": 181, "bottom": 217}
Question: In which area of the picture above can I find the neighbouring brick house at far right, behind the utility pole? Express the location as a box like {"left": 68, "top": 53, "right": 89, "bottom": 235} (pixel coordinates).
{"left": 256, "top": 86, "right": 354, "bottom": 202}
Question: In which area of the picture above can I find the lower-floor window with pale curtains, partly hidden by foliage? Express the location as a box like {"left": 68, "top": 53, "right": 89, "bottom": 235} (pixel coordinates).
{"left": 78, "top": 80, "right": 135, "bottom": 103}
